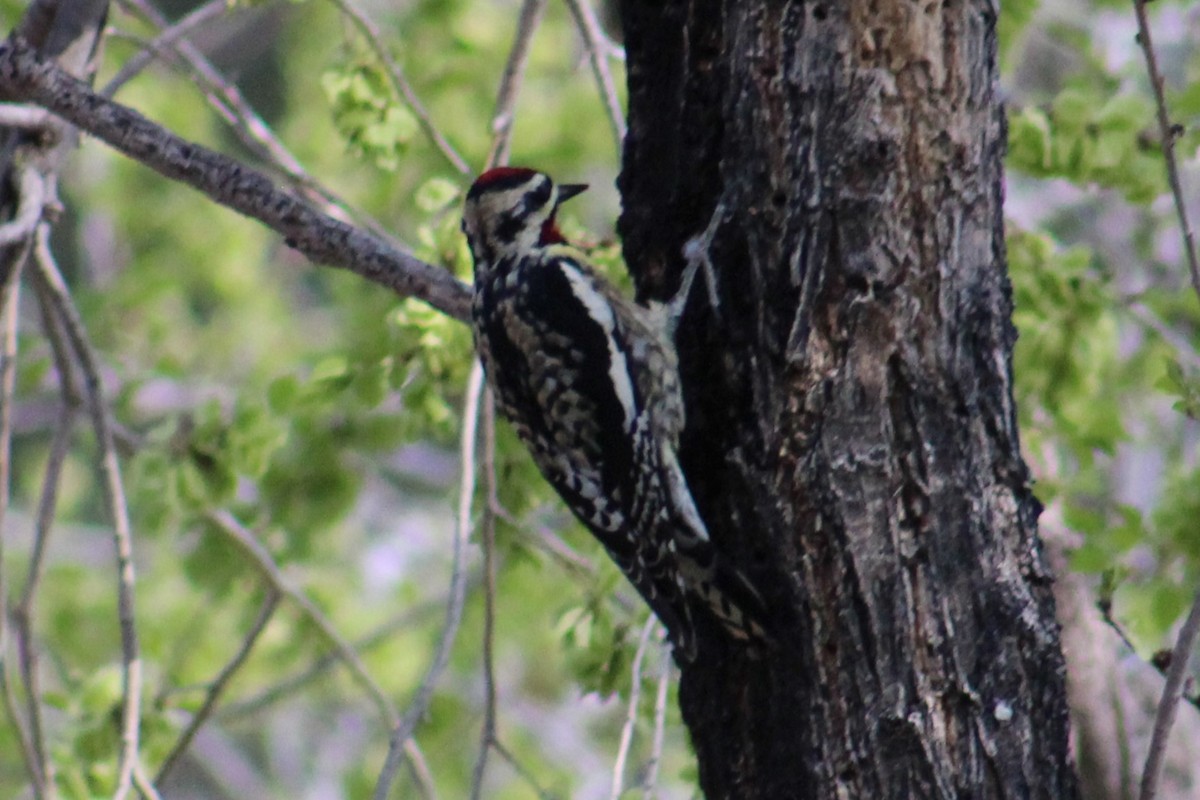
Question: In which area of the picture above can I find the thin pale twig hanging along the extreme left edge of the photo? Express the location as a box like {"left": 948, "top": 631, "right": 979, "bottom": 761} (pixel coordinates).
{"left": 0, "top": 243, "right": 46, "bottom": 800}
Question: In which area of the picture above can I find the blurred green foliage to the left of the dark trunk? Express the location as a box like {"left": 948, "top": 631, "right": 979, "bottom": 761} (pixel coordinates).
{"left": 0, "top": 0, "right": 648, "bottom": 799}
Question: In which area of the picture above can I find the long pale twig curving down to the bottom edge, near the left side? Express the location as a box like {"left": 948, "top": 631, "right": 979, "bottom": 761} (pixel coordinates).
{"left": 35, "top": 223, "right": 142, "bottom": 800}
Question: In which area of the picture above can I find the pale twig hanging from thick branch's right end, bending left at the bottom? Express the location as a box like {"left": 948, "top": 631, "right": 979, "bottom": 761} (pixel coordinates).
{"left": 372, "top": 359, "right": 484, "bottom": 800}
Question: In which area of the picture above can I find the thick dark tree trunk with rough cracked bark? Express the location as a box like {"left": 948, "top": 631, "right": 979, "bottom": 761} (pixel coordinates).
{"left": 620, "top": 0, "right": 1078, "bottom": 800}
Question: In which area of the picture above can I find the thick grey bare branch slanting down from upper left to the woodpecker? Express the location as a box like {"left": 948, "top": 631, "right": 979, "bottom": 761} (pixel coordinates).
{"left": 0, "top": 40, "right": 470, "bottom": 320}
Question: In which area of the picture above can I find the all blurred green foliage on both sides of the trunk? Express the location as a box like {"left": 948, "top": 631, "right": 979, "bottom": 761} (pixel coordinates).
{"left": 7, "top": 0, "right": 1200, "bottom": 799}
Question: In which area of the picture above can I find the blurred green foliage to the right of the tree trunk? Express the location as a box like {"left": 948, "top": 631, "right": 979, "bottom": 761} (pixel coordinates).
{"left": 1009, "top": 4, "right": 1200, "bottom": 650}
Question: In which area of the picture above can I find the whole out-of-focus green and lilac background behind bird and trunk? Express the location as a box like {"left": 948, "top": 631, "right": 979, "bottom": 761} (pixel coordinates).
{"left": 0, "top": 0, "right": 1200, "bottom": 800}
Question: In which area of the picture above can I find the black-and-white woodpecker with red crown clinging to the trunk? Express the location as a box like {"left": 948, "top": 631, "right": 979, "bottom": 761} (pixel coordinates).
{"left": 462, "top": 167, "right": 764, "bottom": 660}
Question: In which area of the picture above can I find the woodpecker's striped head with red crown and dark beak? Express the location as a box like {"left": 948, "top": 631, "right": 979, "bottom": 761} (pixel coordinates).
{"left": 462, "top": 167, "right": 587, "bottom": 263}
